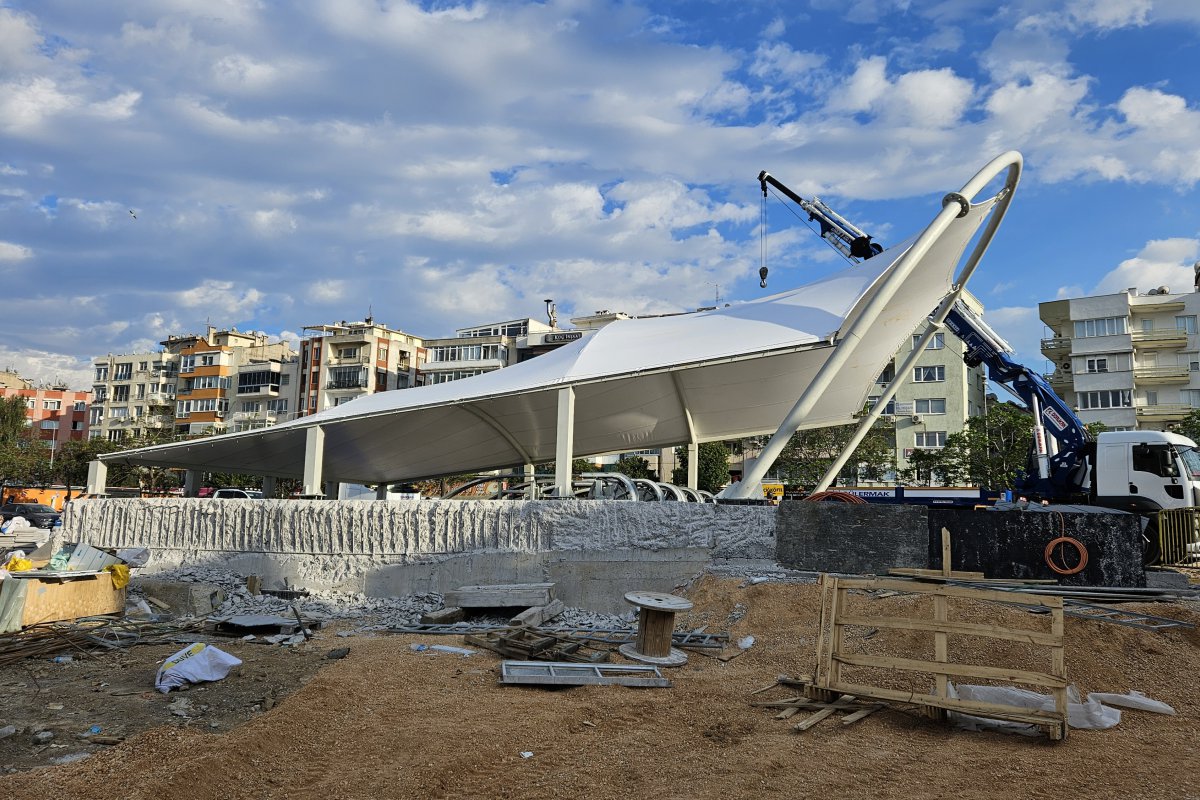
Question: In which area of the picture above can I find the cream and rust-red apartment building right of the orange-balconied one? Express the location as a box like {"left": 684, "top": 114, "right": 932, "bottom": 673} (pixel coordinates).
{"left": 292, "top": 317, "right": 425, "bottom": 416}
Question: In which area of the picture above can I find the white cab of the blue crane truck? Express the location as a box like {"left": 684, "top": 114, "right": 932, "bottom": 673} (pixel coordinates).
{"left": 1092, "top": 431, "right": 1200, "bottom": 512}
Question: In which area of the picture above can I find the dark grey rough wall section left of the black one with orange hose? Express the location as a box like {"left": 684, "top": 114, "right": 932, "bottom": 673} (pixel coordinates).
{"left": 775, "top": 500, "right": 929, "bottom": 575}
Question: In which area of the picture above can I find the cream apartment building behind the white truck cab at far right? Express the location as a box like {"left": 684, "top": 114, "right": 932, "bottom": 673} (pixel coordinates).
{"left": 1038, "top": 273, "right": 1200, "bottom": 431}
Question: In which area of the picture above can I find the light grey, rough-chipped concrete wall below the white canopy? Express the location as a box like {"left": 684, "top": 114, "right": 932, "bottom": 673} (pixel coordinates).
{"left": 64, "top": 499, "right": 775, "bottom": 610}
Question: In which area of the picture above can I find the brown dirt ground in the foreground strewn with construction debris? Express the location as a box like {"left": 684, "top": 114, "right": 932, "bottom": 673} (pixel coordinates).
{"left": 0, "top": 577, "right": 1200, "bottom": 800}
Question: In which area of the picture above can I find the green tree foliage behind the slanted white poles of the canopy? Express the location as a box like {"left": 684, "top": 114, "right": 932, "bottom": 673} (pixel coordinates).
{"left": 774, "top": 421, "right": 895, "bottom": 487}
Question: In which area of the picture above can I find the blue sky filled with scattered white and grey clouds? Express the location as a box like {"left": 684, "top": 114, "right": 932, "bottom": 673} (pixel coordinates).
{"left": 0, "top": 0, "right": 1200, "bottom": 390}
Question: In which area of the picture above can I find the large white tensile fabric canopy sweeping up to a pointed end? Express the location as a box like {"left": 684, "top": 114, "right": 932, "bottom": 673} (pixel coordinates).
{"left": 102, "top": 153, "right": 1022, "bottom": 483}
